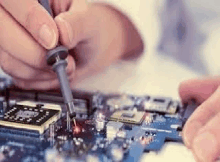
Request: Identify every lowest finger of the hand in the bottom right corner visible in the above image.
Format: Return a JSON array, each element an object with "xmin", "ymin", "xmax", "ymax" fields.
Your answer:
[{"xmin": 192, "ymin": 112, "xmax": 220, "ymax": 162}]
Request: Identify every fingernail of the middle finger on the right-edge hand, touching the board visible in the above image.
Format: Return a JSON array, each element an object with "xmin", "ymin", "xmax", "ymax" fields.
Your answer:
[{"xmin": 183, "ymin": 121, "xmax": 202, "ymax": 148}]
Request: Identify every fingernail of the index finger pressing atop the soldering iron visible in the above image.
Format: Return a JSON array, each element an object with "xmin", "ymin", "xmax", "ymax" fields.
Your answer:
[{"xmin": 39, "ymin": 24, "xmax": 56, "ymax": 49}]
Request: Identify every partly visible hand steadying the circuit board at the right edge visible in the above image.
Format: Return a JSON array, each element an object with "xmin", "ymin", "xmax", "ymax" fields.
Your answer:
[{"xmin": 179, "ymin": 77, "xmax": 220, "ymax": 162}]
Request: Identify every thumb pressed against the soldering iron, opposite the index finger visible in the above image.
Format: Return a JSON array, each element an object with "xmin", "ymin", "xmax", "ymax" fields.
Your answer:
[{"xmin": 55, "ymin": 0, "xmax": 88, "ymax": 48}]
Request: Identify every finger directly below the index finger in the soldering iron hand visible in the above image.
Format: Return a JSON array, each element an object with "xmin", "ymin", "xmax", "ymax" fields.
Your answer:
[{"xmin": 0, "ymin": 5, "xmax": 47, "ymax": 69}]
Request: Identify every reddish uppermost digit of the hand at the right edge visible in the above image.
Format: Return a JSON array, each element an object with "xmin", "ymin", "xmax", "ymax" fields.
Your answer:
[{"xmin": 179, "ymin": 77, "xmax": 220, "ymax": 103}]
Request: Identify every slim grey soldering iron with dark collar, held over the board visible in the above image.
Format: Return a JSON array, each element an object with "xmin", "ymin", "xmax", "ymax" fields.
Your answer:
[{"xmin": 39, "ymin": 0, "xmax": 76, "ymax": 126}]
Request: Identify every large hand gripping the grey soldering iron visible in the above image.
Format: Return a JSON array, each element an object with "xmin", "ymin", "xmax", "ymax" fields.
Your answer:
[{"xmin": 0, "ymin": 0, "xmax": 143, "ymax": 89}]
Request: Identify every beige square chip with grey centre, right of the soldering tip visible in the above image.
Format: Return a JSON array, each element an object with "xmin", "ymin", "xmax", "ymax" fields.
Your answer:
[{"xmin": 110, "ymin": 110, "xmax": 145, "ymax": 124}]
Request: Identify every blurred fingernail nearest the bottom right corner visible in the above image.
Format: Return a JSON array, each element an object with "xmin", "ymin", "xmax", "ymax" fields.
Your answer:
[{"xmin": 193, "ymin": 132, "xmax": 218, "ymax": 162}]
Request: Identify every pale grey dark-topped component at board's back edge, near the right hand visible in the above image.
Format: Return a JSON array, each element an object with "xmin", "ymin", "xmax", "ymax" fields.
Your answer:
[{"xmin": 143, "ymin": 97, "xmax": 178, "ymax": 114}]
